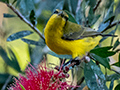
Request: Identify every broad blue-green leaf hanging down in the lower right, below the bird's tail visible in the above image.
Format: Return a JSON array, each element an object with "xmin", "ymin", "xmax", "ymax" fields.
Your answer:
[{"xmin": 84, "ymin": 60, "xmax": 108, "ymax": 90}]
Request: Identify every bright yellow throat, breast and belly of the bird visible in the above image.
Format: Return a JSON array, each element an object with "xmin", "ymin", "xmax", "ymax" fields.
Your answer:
[{"xmin": 44, "ymin": 14, "xmax": 101, "ymax": 58}]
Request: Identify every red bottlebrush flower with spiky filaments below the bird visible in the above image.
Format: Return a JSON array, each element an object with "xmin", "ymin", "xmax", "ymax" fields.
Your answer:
[{"xmin": 8, "ymin": 62, "xmax": 72, "ymax": 90}]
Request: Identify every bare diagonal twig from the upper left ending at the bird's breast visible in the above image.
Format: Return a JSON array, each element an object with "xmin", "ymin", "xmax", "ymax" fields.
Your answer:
[{"xmin": 7, "ymin": 4, "xmax": 45, "ymax": 40}]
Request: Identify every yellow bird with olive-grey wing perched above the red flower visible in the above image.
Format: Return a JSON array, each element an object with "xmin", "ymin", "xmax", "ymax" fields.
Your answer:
[{"xmin": 44, "ymin": 9, "xmax": 102, "ymax": 59}]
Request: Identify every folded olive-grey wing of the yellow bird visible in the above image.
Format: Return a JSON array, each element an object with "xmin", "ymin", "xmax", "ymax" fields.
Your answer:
[{"xmin": 62, "ymin": 21, "xmax": 101, "ymax": 40}]
